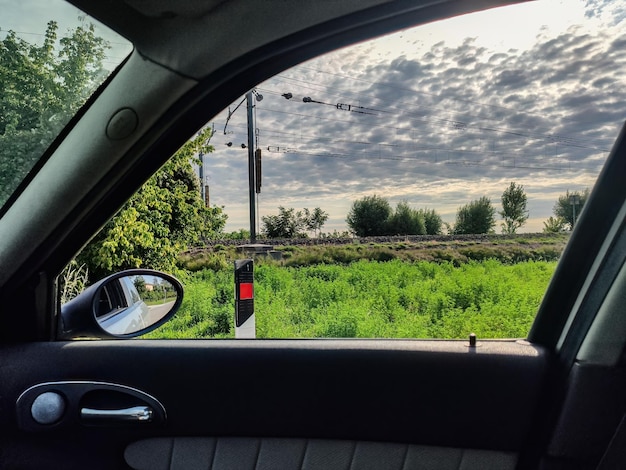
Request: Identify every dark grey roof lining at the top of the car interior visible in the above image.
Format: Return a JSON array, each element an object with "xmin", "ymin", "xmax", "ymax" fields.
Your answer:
[{"xmin": 71, "ymin": 0, "xmax": 518, "ymax": 79}]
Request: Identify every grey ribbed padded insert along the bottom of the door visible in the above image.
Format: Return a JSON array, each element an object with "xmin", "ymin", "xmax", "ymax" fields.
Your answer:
[{"xmin": 124, "ymin": 437, "xmax": 517, "ymax": 470}]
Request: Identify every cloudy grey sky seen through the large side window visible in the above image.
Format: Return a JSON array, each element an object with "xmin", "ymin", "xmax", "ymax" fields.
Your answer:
[{"xmin": 199, "ymin": 0, "xmax": 626, "ymax": 232}]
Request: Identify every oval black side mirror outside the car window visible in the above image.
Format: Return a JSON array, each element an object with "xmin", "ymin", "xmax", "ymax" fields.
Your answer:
[{"xmin": 58, "ymin": 269, "xmax": 183, "ymax": 339}]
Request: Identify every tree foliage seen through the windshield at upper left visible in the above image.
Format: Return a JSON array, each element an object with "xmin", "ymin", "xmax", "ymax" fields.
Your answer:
[{"xmin": 0, "ymin": 21, "xmax": 108, "ymax": 204}]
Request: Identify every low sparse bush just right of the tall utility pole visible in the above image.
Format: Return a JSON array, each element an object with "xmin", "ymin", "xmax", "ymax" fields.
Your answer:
[{"xmin": 261, "ymin": 206, "xmax": 328, "ymax": 238}]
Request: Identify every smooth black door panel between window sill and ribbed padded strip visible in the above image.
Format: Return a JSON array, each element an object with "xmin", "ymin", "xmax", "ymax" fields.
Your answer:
[{"xmin": 0, "ymin": 340, "xmax": 549, "ymax": 468}]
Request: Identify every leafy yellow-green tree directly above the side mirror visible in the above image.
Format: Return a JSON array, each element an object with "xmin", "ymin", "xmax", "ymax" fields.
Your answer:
[{"xmin": 78, "ymin": 128, "xmax": 227, "ymax": 278}]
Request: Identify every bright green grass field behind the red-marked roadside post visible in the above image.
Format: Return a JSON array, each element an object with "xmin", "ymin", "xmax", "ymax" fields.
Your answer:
[{"xmin": 146, "ymin": 259, "xmax": 556, "ymax": 339}]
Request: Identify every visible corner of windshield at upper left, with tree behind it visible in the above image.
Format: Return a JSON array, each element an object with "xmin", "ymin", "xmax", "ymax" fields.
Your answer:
[{"xmin": 0, "ymin": 0, "xmax": 131, "ymax": 209}]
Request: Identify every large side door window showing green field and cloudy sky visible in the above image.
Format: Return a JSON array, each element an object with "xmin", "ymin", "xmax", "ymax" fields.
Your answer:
[{"xmin": 61, "ymin": 2, "xmax": 626, "ymax": 338}]
